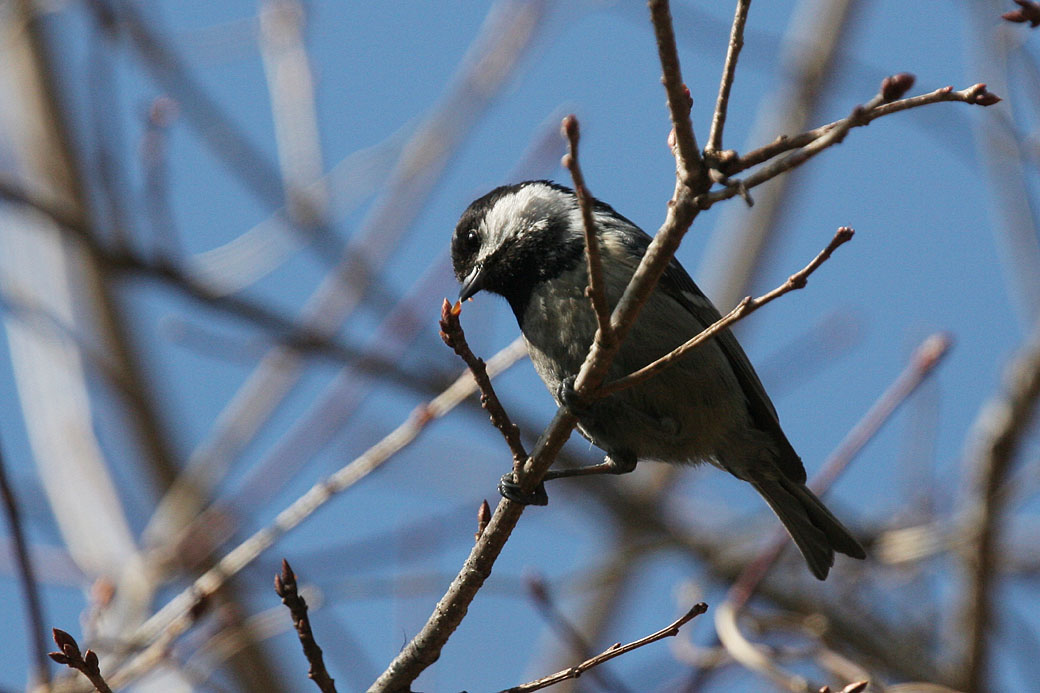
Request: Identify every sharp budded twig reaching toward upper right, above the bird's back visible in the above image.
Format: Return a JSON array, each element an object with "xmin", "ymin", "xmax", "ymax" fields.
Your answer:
[{"xmin": 709, "ymin": 79, "xmax": 1000, "ymax": 178}]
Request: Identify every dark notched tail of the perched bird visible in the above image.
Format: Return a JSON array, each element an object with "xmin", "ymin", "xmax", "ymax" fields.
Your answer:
[{"xmin": 751, "ymin": 478, "xmax": 866, "ymax": 580}]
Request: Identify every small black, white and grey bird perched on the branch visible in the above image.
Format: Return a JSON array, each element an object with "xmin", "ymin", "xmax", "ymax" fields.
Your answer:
[{"xmin": 451, "ymin": 180, "xmax": 865, "ymax": 580}]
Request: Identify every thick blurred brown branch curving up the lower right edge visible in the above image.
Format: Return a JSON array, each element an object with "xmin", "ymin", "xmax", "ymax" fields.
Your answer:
[{"xmin": 962, "ymin": 322, "xmax": 1040, "ymax": 692}]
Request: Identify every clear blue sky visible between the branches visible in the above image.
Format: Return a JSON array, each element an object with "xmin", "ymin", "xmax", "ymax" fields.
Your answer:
[{"xmin": 0, "ymin": 0, "xmax": 1037, "ymax": 691}]
